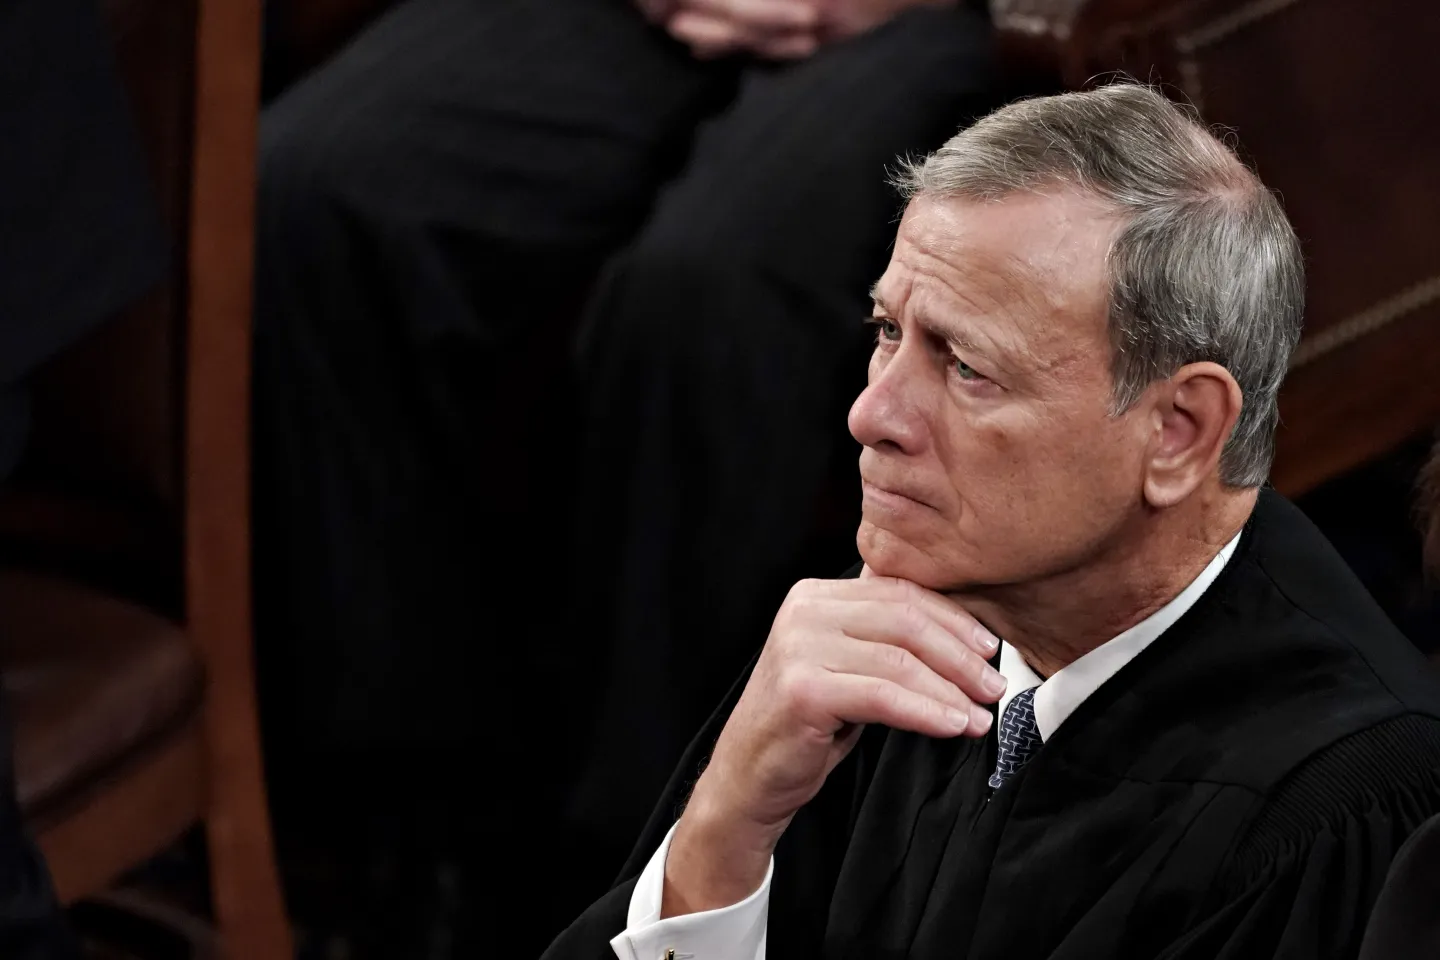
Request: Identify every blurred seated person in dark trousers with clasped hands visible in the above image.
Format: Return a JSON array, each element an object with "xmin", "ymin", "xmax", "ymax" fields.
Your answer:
[{"xmin": 247, "ymin": 0, "xmax": 1019, "ymax": 949}]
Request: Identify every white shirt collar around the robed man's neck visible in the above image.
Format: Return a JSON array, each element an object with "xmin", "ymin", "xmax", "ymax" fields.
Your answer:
[{"xmin": 998, "ymin": 534, "xmax": 1240, "ymax": 741}]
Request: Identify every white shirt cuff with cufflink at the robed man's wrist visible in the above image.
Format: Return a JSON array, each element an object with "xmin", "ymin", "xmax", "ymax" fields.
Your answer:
[{"xmin": 611, "ymin": 826, "xmax": 775, "ymax": 960}]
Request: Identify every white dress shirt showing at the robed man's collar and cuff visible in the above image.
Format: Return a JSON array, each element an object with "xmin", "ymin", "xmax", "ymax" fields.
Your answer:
[{"xmin": 611, "ymin": 534, "xmax": 1240, "ymax": 960}]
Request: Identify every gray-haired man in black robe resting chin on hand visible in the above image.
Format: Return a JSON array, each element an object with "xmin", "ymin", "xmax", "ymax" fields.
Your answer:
[{"xmin": 547, "ymin": 85, "xmax": 1440, "ymax": 960}]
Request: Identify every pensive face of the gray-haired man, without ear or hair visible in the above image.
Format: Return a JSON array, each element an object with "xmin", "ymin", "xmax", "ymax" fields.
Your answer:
[{"xmin": 850, "ymin": 190, "xmax": 1151, "ymax": 590}]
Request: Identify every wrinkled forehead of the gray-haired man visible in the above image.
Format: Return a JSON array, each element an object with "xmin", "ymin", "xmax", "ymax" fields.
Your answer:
[{"xmin": 873, "ymin": 191, "xmax": 1119, "ymax": 374}]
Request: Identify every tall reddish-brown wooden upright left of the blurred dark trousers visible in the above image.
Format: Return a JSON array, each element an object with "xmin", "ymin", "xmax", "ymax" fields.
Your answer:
[{"xmin": 184, "ymin": 0, "xmax": 292, "ymax": 959}]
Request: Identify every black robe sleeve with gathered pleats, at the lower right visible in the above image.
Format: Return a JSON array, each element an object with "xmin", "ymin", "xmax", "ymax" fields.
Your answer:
[{"xmin": 1152, "ymin": 715, "xmax": 1440, "ymax": 960}]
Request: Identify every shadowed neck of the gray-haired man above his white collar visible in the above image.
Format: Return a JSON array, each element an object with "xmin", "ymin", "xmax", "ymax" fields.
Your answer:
[{"xmin": 956, "ymin": 489, "xmax": 1257, "ymax": 676}]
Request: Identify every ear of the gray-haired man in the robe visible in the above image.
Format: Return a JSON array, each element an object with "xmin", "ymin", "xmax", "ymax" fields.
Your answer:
[{"xmin": 1145, "ymin": 363, "xmax": 1241, "ymax": 507}]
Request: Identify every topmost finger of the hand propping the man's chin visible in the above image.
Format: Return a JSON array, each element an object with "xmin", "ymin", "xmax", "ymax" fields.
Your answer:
[{"xmin": 834, "ymin": 602, "xmax": 1005, "ymax": 704}]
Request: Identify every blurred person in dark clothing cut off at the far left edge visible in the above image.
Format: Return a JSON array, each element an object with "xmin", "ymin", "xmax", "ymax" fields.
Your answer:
[{"xmin": 0, "ymin": 0, "xmax": 166, "ymax": 960}]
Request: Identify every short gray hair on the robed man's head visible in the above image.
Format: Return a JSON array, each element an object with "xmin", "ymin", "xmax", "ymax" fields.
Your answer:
[{"xmin": 896, "ymin": 83, "xmax": 1305, "ymax": 486}]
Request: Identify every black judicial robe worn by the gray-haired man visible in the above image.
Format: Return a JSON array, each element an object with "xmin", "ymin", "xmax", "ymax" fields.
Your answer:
[{"xmin": 546, "ymin": 491, "xmax": 1440, "ymax": 960}]
